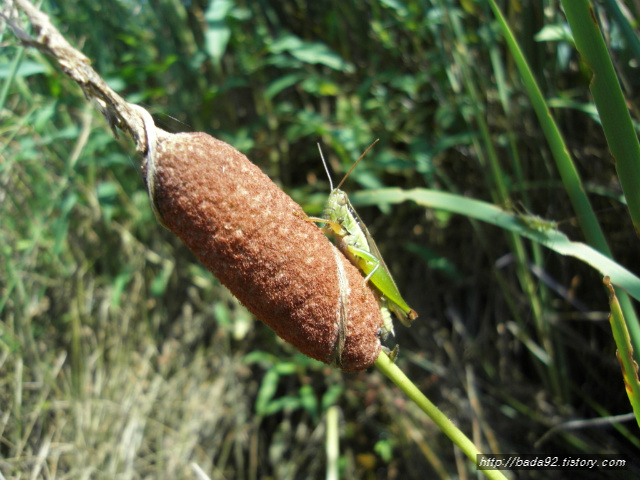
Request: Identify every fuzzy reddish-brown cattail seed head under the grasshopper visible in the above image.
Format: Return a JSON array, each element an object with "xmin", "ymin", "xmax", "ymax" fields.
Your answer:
[{"xmin": 147, "ymin": 133, "xmax": 382, "ymax": 372}]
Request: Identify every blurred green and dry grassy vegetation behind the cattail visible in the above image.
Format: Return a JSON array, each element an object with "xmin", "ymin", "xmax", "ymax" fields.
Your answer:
[{"xmin": 0, "ymin": 0, "xmax": 640, "ymax": 479}]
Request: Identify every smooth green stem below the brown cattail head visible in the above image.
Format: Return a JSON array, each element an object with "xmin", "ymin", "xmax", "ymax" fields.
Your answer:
[{"xmin": 376, "ymin": 352, "xmax": 506, "ymax": 480}]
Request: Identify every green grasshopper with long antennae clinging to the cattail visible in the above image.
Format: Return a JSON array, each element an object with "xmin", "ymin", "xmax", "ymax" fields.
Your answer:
[{"xmin": 309, "ymin": 140, "xmax": 418, "ymax": 339}]
